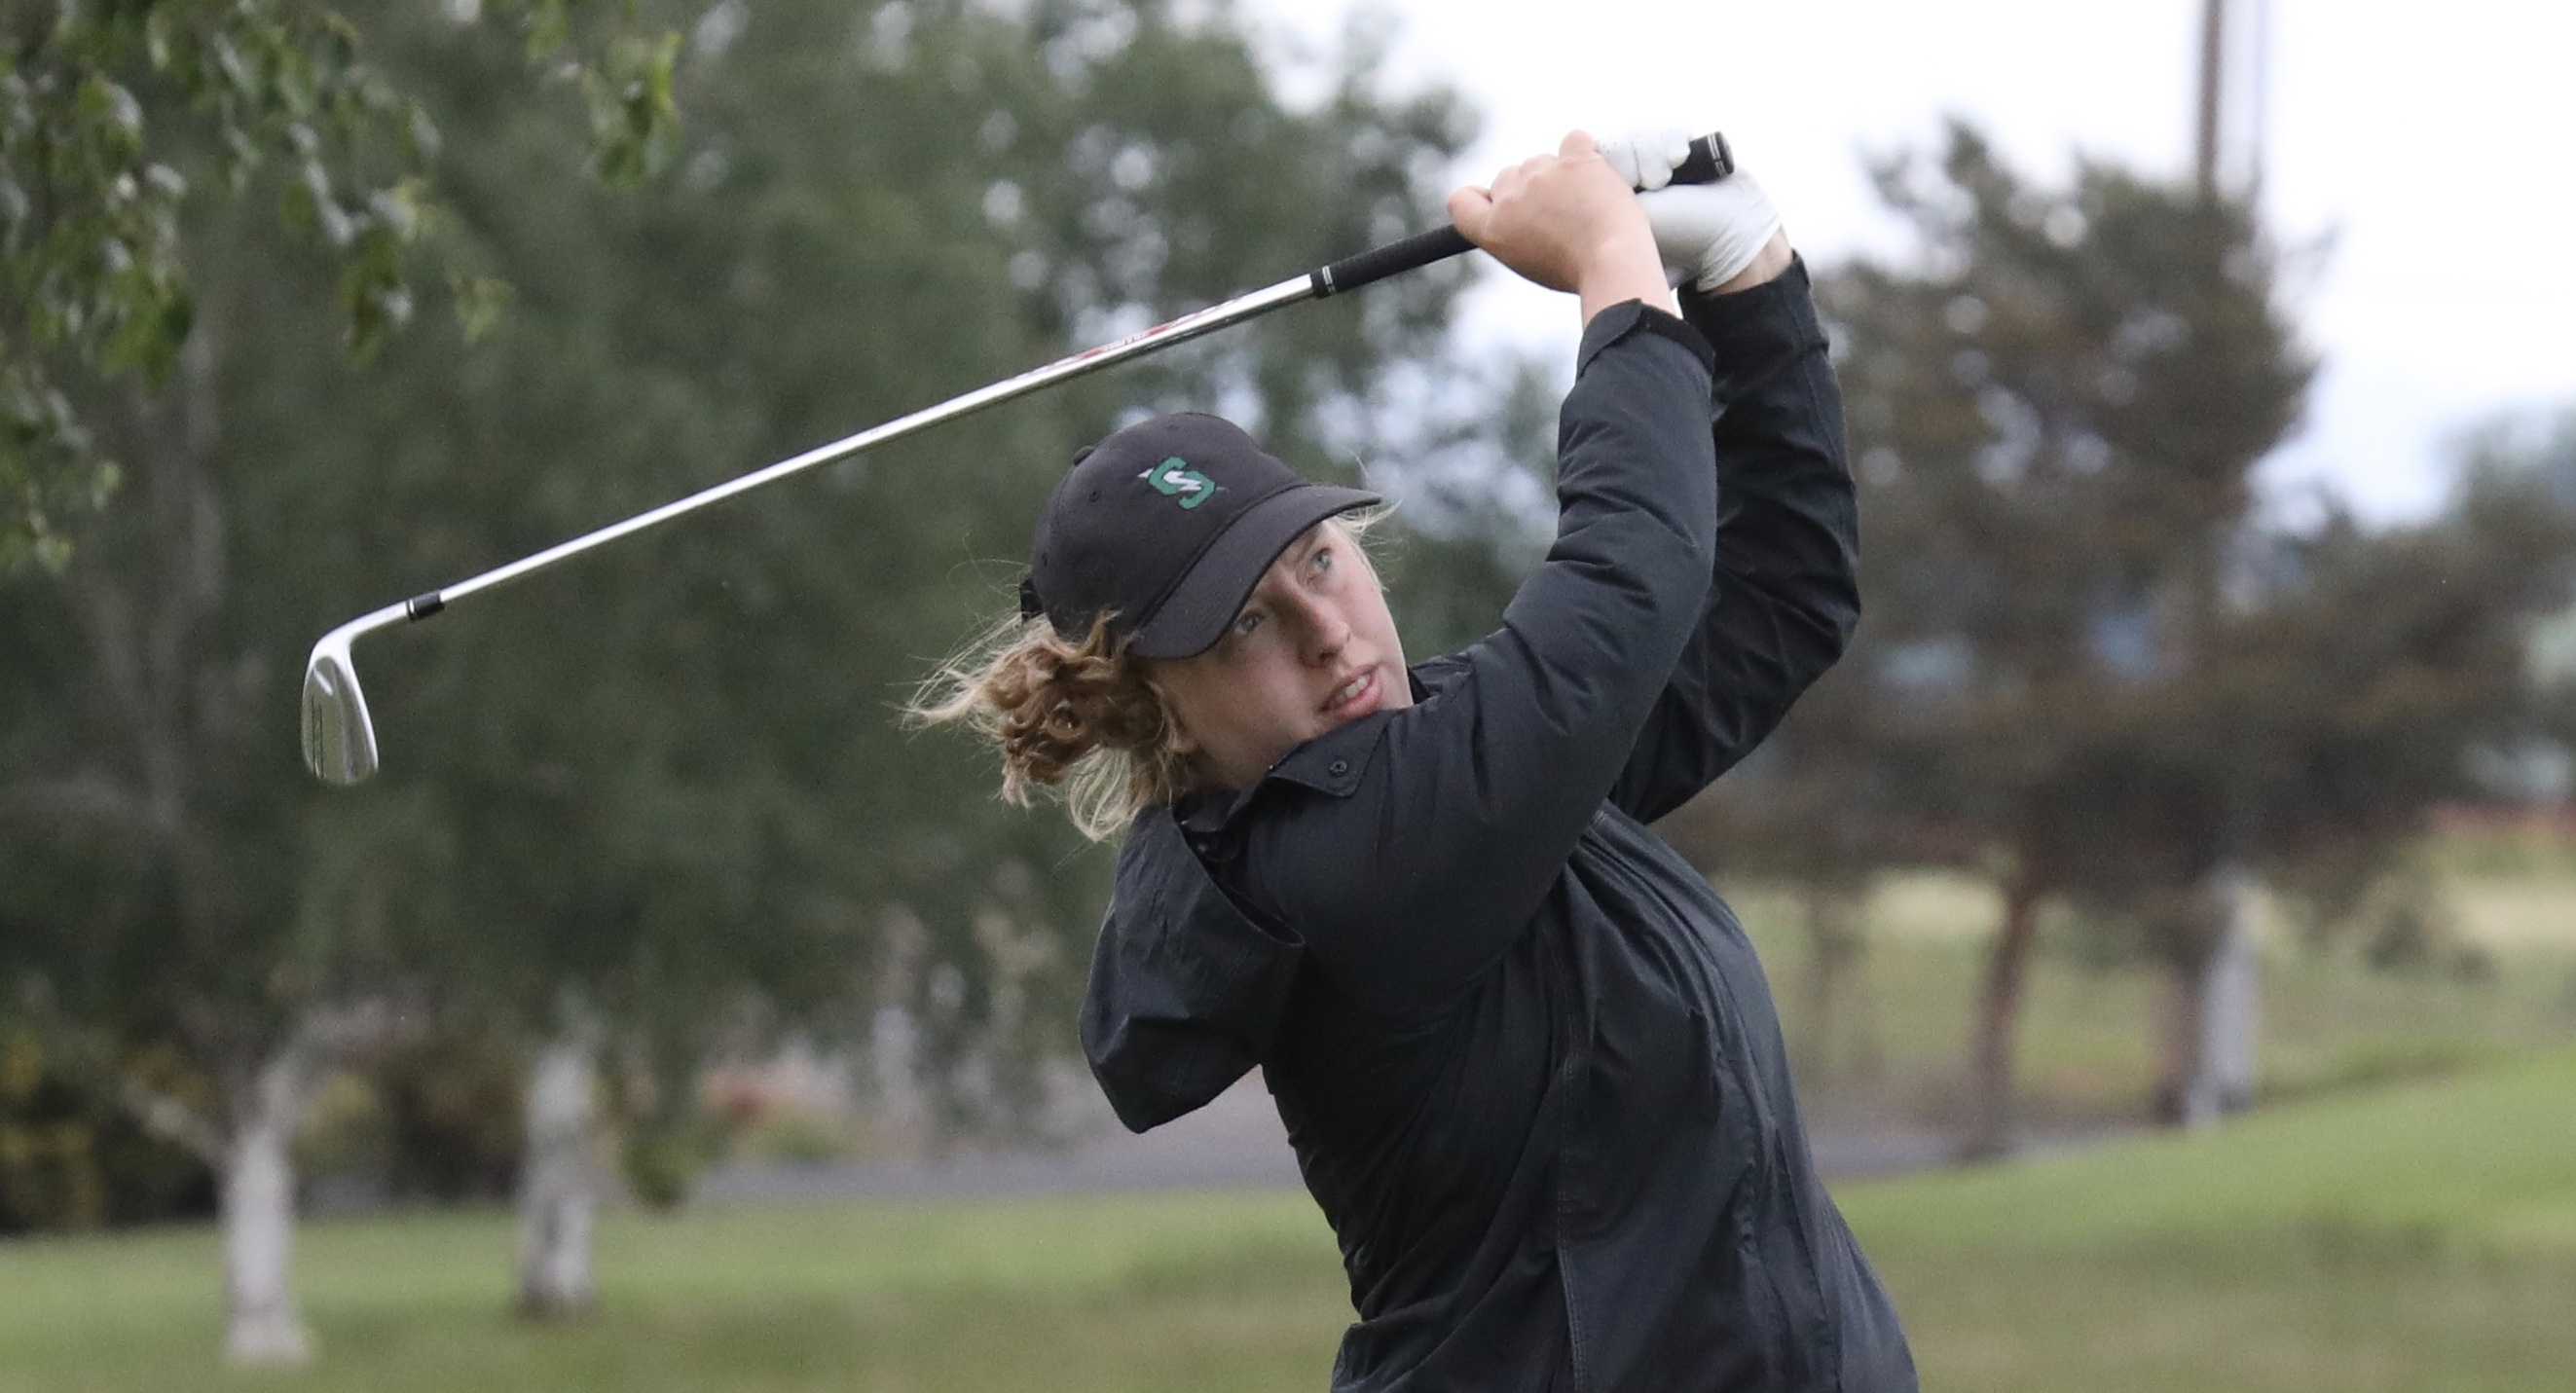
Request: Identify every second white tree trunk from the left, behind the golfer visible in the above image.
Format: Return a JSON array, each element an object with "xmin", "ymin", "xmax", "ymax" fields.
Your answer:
[{"xmin": 518, "ymin": 1008, "xmax": 598, "ymax": 1321}]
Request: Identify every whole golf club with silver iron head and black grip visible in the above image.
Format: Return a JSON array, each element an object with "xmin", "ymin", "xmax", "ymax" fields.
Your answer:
[{"xmin": 304, "ymin": 134, "xmax": 1734, "ymax": 786}]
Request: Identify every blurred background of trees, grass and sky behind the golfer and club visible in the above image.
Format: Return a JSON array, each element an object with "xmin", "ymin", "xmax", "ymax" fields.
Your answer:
[{"xmin": 0, "ymin": 0, "xmax": 2576, "ymax": 1390}]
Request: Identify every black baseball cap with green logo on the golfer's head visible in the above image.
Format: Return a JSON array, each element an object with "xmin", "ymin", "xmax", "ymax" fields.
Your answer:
[{"xmin": 1020, "ymin": 412, "xmax": 1379, "ymax": 659}]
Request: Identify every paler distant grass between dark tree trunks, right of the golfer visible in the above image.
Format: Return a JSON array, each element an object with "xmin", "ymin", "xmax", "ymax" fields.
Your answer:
[{"xmin": 1721, "ymin": 853, "xmax": 2576, "ymax": 1128}]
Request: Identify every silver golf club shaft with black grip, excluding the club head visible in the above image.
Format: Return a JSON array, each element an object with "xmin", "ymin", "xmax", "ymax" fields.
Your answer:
[{"xmin": 368, "ymin": 134, "xmax": 1734, "ymax": 620}]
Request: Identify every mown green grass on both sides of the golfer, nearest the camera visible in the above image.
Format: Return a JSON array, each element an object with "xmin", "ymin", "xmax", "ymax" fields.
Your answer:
[{"xmin": 0, "ymin": 1050, "xmax": 2576, "ymax": 1393}]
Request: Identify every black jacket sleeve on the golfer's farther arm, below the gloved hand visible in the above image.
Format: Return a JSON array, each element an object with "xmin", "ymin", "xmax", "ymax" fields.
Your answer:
[{"xmin": 1610, "ymin": 260, "xmax": 1859, "ymax": 822}]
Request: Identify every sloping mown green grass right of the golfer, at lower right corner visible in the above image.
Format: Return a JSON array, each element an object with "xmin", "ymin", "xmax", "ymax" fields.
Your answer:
[{"xmin": 1847, "ymin": 1053, "xmax": 2576, "ymax": 1393}]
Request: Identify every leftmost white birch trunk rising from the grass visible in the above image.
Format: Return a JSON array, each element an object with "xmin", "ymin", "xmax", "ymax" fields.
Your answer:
[{"xmin": 222, "ymin": 1048, "xmax": 312, "ymax": 1368}]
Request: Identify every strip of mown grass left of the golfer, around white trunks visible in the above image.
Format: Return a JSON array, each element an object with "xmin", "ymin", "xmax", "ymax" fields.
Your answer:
[{"xmin": 0, "ymin": 1192, "xmax": 1347, "ymax": 1393}]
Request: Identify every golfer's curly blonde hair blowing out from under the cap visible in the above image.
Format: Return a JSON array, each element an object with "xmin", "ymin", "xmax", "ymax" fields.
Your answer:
[{"xmin": 904, "ymin": 507, "xmax": 1391, "ymax": 842}]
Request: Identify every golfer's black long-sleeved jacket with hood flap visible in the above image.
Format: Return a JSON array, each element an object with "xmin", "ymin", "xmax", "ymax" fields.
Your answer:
[{"xmin": 1082, "ymin": 265, "xmax": 1917, "ymax": 1393}]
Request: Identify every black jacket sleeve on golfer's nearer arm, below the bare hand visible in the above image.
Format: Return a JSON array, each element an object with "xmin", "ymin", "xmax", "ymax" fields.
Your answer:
[{"xmin": 1244, "ymin": 301, "xmax": 1715, "ymax": 1014}]
